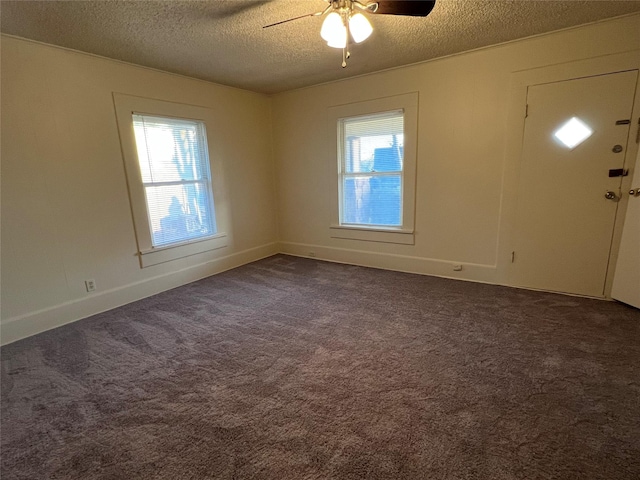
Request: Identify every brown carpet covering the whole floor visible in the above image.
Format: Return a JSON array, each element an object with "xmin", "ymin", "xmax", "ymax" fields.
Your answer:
[{"xmin": 0, "ymin": 255, "xmax": 640, "ymax": 480}]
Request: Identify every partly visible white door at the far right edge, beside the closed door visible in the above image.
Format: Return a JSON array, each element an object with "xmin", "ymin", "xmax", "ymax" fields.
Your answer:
[{"xmin": 611, "ymin": 151, "xmax": 640, "ymax": 308}]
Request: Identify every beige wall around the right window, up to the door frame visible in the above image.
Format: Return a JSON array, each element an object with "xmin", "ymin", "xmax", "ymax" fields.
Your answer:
[{"xmin": 273, "ymin": 15, "xmax": 640, "ymax": 283}]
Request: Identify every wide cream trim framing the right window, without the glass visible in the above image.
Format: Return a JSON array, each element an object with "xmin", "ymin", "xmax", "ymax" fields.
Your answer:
[{"xmin": 328, "ymin": 92, "xmax": 418, "ymax": 245}]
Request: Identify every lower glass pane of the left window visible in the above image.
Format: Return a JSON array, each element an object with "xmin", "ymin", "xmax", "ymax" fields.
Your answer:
[{"xmin": 145, "ymin": 183, "xmax": 216, "ymax": 246}]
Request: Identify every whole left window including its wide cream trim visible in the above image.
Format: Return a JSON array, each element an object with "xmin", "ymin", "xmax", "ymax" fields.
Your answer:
[{"xmin": 113, "ymin": 93, "xmax": 229, "ymax": 268}]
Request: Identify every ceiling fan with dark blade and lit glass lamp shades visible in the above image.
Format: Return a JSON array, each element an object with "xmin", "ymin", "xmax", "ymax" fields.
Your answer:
[{"xmin": 262, "ymin": 0, "xmax": 436, "ymax": 68}]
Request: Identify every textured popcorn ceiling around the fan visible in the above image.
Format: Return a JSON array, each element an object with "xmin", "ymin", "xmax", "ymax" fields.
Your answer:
[{"xmin": 0, "ymin": 0, "xmax": 640, "ymax": 93}]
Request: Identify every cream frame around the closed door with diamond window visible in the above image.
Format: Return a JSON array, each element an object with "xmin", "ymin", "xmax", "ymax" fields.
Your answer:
[{"xmin": 497, "ymin": 50, "xmax": 640, "ymax": 298}]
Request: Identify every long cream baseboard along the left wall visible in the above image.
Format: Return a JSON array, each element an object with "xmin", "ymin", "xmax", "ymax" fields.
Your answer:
[{"xmin": 0, "ymin": 243, "xmax": 278, "ymax": 345}]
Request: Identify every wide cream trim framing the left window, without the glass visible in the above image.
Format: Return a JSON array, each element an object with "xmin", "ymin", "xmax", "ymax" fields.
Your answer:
[{"xmin": 113, "ymin": 93, "xmax": 228, "ymax": 268}]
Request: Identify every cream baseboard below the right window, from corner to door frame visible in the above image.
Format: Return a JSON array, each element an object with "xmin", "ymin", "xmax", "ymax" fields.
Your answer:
[{"xmin": 278, "ymin": 242, "xmax": 498, "ymax": 285}]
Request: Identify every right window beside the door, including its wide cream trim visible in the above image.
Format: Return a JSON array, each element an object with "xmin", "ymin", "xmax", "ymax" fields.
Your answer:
[{"xmin": 328, "ymin": 93, "xmax": 418, "ymax": 245}]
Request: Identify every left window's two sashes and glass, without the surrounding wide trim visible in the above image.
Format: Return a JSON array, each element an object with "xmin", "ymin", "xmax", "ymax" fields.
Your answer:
[{"xmin": 133, "ymin": 114, "xmax": 216, "ymax": 247}]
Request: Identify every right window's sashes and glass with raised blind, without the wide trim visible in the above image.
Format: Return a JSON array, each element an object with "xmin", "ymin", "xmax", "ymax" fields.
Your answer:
[{"xmin": 339, "ymin": 111, "xmax": 404, "ymax": 227}]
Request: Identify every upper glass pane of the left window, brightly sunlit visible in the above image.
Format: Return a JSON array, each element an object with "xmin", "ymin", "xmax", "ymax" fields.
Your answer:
[{"xmin": 133, "ymin": 115, "xmax": 208, "ymax": 183}]
